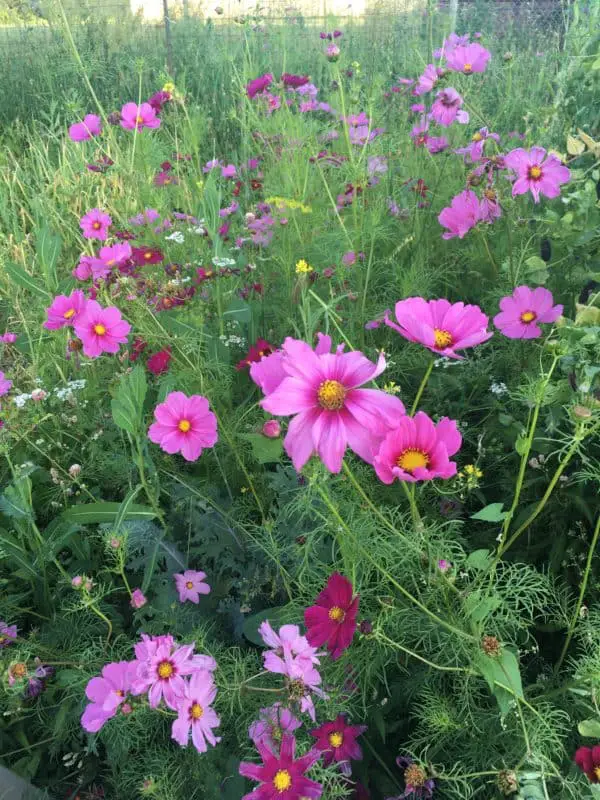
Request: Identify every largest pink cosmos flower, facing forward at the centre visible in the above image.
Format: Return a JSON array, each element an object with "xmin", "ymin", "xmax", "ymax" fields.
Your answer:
[{"xmin": 260, "ymin": 338, "xmax": 404, "ymax": 472}]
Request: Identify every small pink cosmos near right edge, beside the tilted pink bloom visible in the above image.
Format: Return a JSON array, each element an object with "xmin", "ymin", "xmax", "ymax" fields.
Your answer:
[{"xmin": 494, "ymin": 286, "xmax": 563, "ymax": 339}]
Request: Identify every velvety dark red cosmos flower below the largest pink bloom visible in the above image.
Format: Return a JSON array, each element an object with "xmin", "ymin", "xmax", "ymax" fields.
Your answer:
[{"xmin": 304, "ymin": 572, "xmax": 359, "ymax": 660}]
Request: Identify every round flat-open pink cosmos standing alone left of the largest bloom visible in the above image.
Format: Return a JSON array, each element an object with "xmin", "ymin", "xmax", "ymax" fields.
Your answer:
[{"xmin": 148, "ymin": 392, "xmax": 219, "ymax": 461}]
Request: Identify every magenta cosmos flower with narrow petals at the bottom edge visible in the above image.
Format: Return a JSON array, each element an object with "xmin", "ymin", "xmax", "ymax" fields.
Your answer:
[{"xmin": 240, "ymin": 733, "xmax": 323, "ymax": 800}]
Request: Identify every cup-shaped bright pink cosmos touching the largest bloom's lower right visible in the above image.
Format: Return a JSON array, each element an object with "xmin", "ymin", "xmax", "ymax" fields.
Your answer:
[{"xmin": 373, "ymin": 411, "xmax": 462, "ymax": 483}]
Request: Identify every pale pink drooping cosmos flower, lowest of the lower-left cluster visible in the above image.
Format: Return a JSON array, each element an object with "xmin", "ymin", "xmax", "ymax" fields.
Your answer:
[{"xmin": 171, "ymin": 671, "xmax": 221, "ymax": 753}]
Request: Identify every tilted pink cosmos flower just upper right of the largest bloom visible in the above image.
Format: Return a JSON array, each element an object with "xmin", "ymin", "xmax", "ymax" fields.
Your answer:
[{"xmin": 385, "ymin": 297, "xmax": 493, "ymax": 359}]
